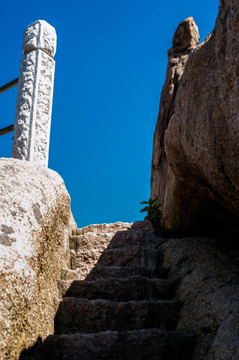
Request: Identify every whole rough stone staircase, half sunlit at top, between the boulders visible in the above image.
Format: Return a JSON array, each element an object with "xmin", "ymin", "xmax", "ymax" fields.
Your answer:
[{"xmin": 22, "ymin": 221, "xmax": 195, "ymax": 360}]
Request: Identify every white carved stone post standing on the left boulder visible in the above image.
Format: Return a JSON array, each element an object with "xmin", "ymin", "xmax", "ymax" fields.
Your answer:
[{"xmin": 12, "ymin": 20, "xmax": 56, "ymax": 167}]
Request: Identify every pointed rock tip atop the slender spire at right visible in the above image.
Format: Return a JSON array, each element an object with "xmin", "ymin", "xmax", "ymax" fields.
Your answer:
[{"xmin": 172, "ymin": 16, "xmax": 200, "ymax": 51}]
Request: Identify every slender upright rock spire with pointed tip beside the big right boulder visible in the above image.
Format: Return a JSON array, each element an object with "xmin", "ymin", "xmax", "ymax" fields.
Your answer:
[{"xmin": 151, "ymin": 18, "xmax": 199, "ymax": 208}]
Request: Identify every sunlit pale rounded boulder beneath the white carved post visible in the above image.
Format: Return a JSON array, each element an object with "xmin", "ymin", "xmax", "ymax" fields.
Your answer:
[{"xmin": 0, "ymin": 159, "xmax": 74, "ymax": 360}]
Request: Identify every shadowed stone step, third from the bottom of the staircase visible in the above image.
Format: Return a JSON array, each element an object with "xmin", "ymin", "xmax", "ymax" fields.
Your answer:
[{"xmin": 63, "ymin": 276, "xmax": 176, "ymax": 301}]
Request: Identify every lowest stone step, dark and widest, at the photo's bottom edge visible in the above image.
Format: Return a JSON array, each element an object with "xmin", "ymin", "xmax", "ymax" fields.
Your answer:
[{"xmin": 25, "ymin": 329, "xmax": 195, "ymax": 360}]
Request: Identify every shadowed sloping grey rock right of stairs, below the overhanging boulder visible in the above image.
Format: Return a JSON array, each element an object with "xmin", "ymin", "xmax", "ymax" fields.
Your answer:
[{"xmin": 162, "ymin": 237, "xmax": 239, "ymax": 360}]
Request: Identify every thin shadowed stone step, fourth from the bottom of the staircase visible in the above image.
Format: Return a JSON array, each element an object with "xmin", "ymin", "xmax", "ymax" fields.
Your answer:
[{"xmin": 86, "ymin": 266, "xmax": 170, "ymax": 280}]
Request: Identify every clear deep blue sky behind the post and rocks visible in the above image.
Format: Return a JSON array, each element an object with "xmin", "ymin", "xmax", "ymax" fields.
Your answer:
[{"xmin": 0, "ymin": 0, "xmax": 219, "ymax": 227}]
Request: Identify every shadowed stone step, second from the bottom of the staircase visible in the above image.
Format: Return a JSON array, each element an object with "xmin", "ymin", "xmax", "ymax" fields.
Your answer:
[{"xmin": 55, "ymin": 297, "xmax": 181, "ymax": 334}]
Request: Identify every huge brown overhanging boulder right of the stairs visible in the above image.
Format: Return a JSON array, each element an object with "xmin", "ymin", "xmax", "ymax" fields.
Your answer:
[{"xmin": 151, "ymin": 0, "xmax": 239, "ymax": 233}]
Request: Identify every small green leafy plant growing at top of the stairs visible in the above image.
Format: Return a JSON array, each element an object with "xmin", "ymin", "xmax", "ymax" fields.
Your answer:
[{"xmin": 140, "ymin": 199, "xmax": 163, "ymax": 232}]
